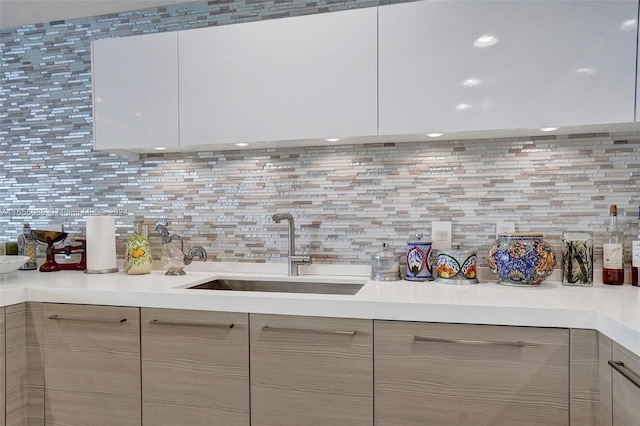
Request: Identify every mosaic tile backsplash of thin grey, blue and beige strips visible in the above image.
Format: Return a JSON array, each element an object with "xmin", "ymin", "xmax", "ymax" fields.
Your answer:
[{"xmin": 0, "ymin": 0, "xmax": 640, "ymax": 264}]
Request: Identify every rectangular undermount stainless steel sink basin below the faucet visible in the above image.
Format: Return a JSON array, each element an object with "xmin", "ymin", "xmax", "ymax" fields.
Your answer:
[{"xmin": 189, "ymin": 279, "xmax": 364, "ymax": 294}]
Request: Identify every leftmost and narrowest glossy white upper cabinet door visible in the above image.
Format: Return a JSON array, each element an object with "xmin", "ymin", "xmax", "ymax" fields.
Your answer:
[{"xmin": 93, "ymin": 33, "xmax": 179, "ymax": 150}]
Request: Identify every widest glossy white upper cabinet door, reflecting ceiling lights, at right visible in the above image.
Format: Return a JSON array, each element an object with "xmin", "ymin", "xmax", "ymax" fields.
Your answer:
[{"xmin": 379, "ymin": 0, "xmax": 638, "ymax": 135}]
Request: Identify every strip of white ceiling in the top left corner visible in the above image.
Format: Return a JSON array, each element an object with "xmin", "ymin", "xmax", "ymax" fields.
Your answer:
[{"xmin": 0, "ymin": 0, "xmax": 193, "ymax": 28}]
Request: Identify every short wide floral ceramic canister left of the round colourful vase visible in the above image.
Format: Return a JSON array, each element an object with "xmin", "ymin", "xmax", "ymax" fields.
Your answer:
[{"xmin": 434, "ymin": 246, "xmax": 478, "ymax": 284}]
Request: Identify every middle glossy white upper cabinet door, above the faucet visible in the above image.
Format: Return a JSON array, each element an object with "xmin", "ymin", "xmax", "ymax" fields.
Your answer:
[{"xmin": 179, "ymin": 7, "xmax": 377, "ymax": 145}]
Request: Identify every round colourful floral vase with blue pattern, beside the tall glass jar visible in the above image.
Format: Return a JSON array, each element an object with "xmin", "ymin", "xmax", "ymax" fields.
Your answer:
[{"xmin": 487, "ymin": 232, "xmax": 556, "ymax": 286}]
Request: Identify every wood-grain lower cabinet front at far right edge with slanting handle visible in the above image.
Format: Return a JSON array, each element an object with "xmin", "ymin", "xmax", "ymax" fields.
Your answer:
[{"xmin": 609, "ymin": 343, "xmax": 640, "ymax": 426}]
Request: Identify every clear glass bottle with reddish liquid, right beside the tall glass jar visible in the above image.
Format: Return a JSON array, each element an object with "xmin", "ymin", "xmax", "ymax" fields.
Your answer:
[{"xmin": 602, "ymin": 204, "xmax": 624, "ymax": 285}]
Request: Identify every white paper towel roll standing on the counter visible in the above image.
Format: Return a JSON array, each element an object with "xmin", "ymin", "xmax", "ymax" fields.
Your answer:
[{"xmin": 85, "ymin": 216, "xmax": 118, "ymax": 274}]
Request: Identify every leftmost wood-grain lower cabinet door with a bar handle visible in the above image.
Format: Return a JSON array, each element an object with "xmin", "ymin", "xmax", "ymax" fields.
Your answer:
[{"xmin": 44, "ymin": 304, "xmax": 142, "ymax": 426}]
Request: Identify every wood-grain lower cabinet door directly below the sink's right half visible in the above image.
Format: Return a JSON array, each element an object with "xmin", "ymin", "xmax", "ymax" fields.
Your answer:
[{"xmin": 250, "ymin": 314, "xmax": 372, "ymax": 426}]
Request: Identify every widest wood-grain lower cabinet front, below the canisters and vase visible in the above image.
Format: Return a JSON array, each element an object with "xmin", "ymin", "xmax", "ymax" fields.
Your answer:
[{"xmin": 374, "ymin": 321, "xmax": 569, "ymax": 426}]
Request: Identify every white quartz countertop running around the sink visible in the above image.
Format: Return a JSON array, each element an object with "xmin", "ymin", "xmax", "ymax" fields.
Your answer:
[{"xmin": 0, "ymin": 263, "xmax": 640, "ymax": 355}]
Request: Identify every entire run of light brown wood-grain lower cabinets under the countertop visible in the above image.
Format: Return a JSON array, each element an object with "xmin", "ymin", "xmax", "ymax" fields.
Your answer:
[{"xmin": 0, "ymin": 303, "xmax": 640, "ymax": 426}]
